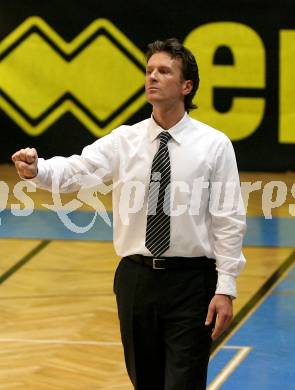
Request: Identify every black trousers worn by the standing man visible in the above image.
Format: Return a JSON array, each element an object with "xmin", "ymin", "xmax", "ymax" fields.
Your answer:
[{"xmin": 114, "ymin": 257, "xmax": 217, "ymax": 390}]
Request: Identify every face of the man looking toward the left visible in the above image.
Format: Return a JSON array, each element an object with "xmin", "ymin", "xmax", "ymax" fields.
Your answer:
[{"xmin": 145, "ymin": 52, "xmax": 187, "ymax": 106}]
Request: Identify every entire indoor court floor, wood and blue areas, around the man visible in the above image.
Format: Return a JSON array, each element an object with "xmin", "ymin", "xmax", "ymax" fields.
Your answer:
[{"xmin": 0, "ymin": 165, "xmax": 295, "ymax": 390}]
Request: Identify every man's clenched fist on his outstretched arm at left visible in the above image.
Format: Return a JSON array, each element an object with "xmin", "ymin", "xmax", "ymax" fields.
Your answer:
[{"xmin": 11, "ymin": 148, "xmax": 38, "ymax": 179}]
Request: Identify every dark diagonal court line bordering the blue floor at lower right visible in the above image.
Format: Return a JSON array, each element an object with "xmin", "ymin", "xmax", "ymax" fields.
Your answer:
[{"xmin": 211, "ymin": 250, "xmax": 295, "ymax": 354}]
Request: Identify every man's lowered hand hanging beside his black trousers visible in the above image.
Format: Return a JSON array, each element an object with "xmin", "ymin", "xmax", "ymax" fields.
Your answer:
[{"xmin": 205, "ymin": 294, "xmax": 233, "ymax": 340}]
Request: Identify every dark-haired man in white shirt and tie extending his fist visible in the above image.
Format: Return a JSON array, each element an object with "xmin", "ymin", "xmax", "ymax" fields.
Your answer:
[{"xmin": 12, "ymin": 39, "xmax": 246, "ymax": 390}]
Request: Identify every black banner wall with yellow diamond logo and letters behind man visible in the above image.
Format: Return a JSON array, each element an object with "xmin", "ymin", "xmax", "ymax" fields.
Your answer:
[{"xmin": 0, "ymin": 0, "xmax": 295, "ymax": 171}]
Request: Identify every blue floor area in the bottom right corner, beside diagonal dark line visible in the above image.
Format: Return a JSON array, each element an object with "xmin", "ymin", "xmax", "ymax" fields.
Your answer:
[{"xmin": 208, "ymin": 269, "xmax": 295, "ymax": 390}]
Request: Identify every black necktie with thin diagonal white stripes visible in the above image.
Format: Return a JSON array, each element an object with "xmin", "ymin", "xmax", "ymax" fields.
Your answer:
[{"xmin": 145, "ymin": 131, "xmax": 171, "ymax": 257}]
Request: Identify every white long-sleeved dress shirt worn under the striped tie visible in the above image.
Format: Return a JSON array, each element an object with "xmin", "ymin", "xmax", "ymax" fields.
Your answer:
[{"xmin": 32, "ymin": 114, "xmax": 246, "ymax": 297}]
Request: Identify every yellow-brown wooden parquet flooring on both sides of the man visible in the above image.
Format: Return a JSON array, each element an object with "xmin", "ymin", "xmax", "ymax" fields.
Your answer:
[{"xmin": 0, "ymin": 166, "xmax": 294, "ymax": 390}]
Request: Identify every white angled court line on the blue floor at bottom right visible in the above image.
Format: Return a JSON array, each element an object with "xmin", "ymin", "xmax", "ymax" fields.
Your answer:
[{"xmin": 207, "ymin": 345, "xmax": 252, "ymax": 390}]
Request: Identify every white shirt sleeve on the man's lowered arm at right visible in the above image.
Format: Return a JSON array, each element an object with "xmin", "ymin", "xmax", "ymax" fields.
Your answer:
[{"xmin": 209, "ymin": 138, "xmax": 246, "ymax": 298}]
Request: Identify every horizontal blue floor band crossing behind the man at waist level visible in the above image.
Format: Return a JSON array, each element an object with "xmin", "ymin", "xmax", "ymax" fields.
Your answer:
[{"xmin": 0, "ymin": 209, "xmax": 295, "ymax": 247}]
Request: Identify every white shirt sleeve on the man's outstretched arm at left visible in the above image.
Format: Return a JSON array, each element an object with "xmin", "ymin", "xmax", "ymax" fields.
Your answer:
[{"xmin": 29, "ymin": 131, "xmax": 118, "ymax": 192}]
